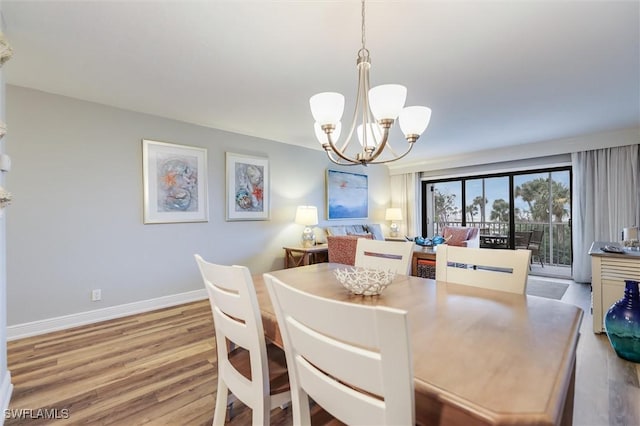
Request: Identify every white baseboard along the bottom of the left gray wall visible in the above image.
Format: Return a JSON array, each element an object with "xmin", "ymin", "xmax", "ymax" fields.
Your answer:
[{"xmin": 7, "ymin": 289, "xmax": 208, "ymax": 341}]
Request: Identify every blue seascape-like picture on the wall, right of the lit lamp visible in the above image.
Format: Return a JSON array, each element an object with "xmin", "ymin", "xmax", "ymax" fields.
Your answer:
[{"xmin": 326, "ymin": 169, "xmax": 369, "ymax": 220}]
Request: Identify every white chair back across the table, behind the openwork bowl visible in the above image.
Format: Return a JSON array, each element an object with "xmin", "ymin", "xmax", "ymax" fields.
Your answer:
[{"xmin": 355, "ymin": 238, "xmax": 414, "ymax": 275}]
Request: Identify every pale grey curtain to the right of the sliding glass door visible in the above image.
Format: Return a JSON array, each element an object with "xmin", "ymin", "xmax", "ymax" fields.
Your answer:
[{"xmin": 571, "ymin": 144, "xmax": 640, "ymax": 283}]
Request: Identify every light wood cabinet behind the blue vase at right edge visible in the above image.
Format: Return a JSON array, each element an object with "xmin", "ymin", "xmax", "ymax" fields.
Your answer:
[{"xmin": 589, "ymin": 241, "xmax": 640, "ymax": 333}]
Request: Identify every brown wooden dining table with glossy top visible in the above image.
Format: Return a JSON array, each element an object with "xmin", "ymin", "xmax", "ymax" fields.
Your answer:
[{"xmin": 254, "ymin": 263, "xmax": 583, "ymax": 425}]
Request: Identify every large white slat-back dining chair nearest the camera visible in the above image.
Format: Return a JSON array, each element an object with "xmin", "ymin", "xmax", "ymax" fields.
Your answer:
[{"xmin": 264, "ymin": 273, "xmax": 415, "ymax": 425}]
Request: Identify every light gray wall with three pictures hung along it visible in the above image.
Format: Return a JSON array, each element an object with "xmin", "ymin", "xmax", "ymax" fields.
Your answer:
[{"xmin": 6, "ymin": 86, "xmax": 390, "ymax": 325}]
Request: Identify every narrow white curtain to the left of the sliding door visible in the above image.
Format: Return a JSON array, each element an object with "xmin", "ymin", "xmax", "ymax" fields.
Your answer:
[{"xmin": 391, "ymin": 173, "xmax": 420, "ymax": 237}]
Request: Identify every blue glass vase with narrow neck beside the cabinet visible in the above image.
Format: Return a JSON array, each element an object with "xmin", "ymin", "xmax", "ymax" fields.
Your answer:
[{"xmin": 604, "ymin": 280, "xmax": 640, "ymax": 362}]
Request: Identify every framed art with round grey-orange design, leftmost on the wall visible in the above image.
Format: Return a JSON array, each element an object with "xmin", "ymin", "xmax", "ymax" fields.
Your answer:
[{"xmin": 142, "ymin": 139, "xmax": 209, "ymax": 224}]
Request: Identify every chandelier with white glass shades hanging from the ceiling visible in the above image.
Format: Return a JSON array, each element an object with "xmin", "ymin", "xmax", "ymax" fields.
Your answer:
[{"xmin": 309, "ymin": 0, "xmax": 431, "ymax": 166}]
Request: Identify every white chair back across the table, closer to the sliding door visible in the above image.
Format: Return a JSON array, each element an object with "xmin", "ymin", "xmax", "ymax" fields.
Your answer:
[{"xmin": 436, "ymin": 244, "xmax": 531, "ymax": 294}]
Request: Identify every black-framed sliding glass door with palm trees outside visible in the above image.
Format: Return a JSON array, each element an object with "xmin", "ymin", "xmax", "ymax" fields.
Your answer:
[{"xmin": 422, "ymin": 167, "xmax": 572, "ymax": 276}]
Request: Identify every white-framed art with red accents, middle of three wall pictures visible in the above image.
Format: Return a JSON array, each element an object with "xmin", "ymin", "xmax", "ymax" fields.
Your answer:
[{"xmin": 226, "ymin": 152, "xmax": 271, "ymax": 221}]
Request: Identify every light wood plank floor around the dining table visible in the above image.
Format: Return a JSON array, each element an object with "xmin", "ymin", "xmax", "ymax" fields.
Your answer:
[{"xmin": 5, "ymin": 283, "xmax": 640, "ymax": 426}]
